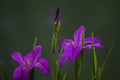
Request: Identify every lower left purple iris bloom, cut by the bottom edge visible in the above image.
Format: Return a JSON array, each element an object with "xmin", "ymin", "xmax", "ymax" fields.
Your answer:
[{"xmin": 11, "ymin": 45, "xmax": 49, "ymax": 80}]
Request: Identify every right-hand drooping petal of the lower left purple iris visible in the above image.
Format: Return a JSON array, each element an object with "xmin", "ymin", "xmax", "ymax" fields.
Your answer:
[{"xmin": 34, "ymin": 58, "xmax": 50, "ymax": 75}]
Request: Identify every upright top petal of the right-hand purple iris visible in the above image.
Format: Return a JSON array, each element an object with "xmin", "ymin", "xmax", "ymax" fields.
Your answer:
[{"xmin": 74, "ymin": 25, "xmax": 85, "ymax": 45}]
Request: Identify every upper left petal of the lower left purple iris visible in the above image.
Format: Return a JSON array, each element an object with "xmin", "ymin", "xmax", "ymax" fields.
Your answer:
[{"xmin": 11, "ymin": 52, "xmax": 25, "ymax": 65}]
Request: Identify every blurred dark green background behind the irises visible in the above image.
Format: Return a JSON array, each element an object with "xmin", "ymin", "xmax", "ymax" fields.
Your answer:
[{"xmin": 0, "ymin": 0, "xmax": 120, "ymax": 80}]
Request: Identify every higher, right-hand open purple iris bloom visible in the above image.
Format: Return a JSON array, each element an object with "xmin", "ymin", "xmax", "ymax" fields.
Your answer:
[{"xmin": 59, "ymin": 25, "xmax": 103, "ymax": 67}]
